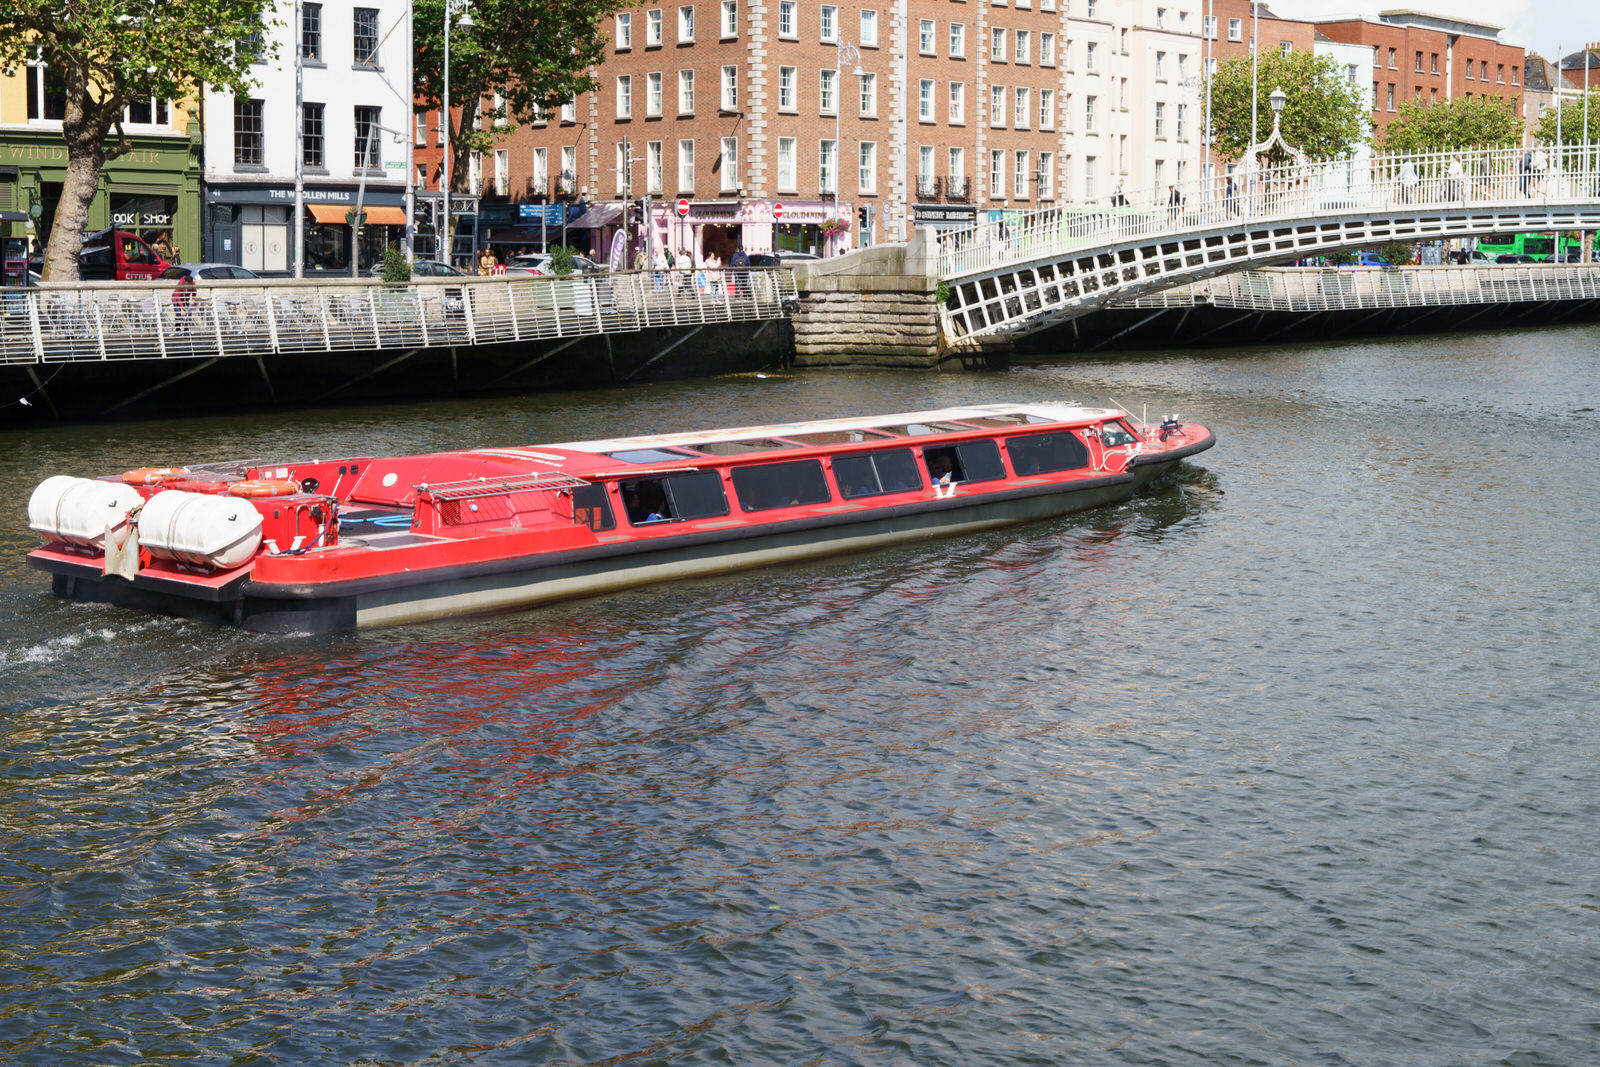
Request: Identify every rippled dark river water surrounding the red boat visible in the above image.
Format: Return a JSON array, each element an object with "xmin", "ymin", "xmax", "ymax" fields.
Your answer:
[{"xmin": 0, "ymin": 326, "xmax": 1600, "ymax": 1065}]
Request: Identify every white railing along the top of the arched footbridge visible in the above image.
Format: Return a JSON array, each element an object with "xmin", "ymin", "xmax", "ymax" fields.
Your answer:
[{"xmin": 938, "ymin": 146, "xmax": 1600, "ymax": 278}]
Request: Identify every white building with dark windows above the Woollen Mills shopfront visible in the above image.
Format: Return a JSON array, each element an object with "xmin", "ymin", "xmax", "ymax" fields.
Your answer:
[{"xmin": 202, "ymin": 0, "xmax": 413, "ymax": 275}]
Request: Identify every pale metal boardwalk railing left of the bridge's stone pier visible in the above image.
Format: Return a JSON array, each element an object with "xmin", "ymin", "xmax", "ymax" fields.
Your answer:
[{"xmin": 0, "ymin": 267, "xmax": 797, "ymax": 363}]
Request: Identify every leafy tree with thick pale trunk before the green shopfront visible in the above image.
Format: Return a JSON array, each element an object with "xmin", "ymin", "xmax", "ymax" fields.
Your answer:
[{"xmin": 0, "ymin": 0, "xmax": 267, "ymax": 282}]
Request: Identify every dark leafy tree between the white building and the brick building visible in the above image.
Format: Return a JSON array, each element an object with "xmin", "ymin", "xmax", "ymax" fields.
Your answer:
[{"xmin": 411, "ymin": 0, "xmax": 622, "ymax": 192}]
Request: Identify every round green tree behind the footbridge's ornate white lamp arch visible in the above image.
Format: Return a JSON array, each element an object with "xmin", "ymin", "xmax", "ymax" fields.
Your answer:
[{"xmin": 1211, "ymin": 51, "xmax": 1373, "ymax": 160}]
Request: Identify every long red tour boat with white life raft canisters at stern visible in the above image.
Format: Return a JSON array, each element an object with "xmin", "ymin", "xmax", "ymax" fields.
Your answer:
[{"xmin": 27, "ymin": 403, "xmax": 1214, "ymax": 632}]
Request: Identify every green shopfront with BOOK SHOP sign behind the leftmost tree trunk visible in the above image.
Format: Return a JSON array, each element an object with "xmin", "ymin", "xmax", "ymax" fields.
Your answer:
[{"xmin": 0, "ymin": 130, "xmax": 200, "ymax": 273}]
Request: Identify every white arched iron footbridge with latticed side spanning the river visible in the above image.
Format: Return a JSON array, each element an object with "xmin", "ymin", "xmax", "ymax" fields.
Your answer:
[{"xmin": 936, "ymin": 147, "xmax": 1600, "ymax": 347}]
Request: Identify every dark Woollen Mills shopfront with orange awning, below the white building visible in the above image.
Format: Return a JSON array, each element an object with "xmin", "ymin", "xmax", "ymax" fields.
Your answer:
[{"xmin": 205, "ymin": 184, "xmax": 406, "ymax": 277}]
